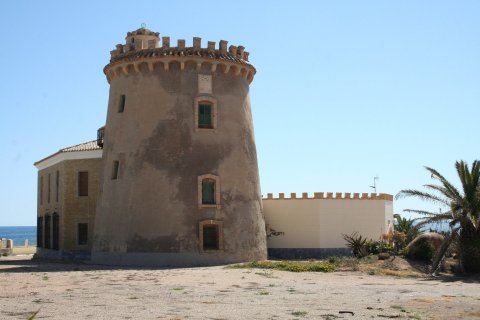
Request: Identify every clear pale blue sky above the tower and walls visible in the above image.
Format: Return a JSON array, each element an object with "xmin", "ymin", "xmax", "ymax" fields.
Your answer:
[{"xmin": 0, "ymin": 0, "xmax": 480, "ymax": 226}]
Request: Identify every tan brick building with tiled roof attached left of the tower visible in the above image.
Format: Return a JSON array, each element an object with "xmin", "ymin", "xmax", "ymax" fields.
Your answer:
[{"xmin": 35, "ymin": 141, "xmax": 102, "ymax": 258}]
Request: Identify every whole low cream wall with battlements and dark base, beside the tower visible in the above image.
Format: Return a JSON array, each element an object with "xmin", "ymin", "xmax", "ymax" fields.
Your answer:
[{"xmin": 263, "ymin": 192, "xmax": 393, "ymax": 259}]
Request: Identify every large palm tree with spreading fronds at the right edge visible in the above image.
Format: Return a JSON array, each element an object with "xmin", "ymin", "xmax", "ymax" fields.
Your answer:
[{"xmin": 395, "ymin": 160, "xmax": 480, "ymax": 273}]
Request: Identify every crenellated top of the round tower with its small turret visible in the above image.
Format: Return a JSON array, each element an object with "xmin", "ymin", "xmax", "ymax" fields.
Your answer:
[{"xmin": 103, "ymin": 28, "xmax": 256, "ymax": 83}]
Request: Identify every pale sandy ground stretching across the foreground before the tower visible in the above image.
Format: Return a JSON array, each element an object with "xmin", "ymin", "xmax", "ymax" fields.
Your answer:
[{"xmin": 0, "ymin": 256, "xmax": 480, "ymax": 320}]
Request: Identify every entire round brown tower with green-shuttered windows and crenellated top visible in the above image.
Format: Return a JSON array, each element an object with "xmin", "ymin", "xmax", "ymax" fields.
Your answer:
[{"xmin": 92, "ymin": 28, "xmax": 267, "ymax": 266}]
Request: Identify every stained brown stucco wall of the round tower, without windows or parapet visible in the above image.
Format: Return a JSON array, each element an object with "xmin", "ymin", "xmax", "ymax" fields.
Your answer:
[{"xmin": 92, "ymin": 45, "xmax": 266, "ymax": 265}]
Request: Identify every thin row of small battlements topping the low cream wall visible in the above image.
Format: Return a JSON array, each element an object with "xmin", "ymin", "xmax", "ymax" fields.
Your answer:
[{"xmin": 263, "ymin": 192, "xmax": 393, "ymax": 201}]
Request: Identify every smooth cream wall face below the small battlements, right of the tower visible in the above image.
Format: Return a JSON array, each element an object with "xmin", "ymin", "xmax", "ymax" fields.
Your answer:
[{"xmin": 263, "ymin": 195, "xmax": 393, "ymax": 248}]
